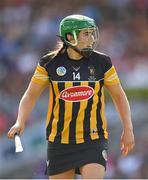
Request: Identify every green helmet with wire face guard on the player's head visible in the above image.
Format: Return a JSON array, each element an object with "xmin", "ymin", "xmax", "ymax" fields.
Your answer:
[{"xmin": 60, "ymin": 15, "xmax": 99, "ymax": 56}]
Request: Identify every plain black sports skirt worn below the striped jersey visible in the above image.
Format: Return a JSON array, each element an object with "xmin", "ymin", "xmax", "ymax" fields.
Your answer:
[{"xmin": 46, "ymin": 139, "xmax": 108, "ymax": 176}]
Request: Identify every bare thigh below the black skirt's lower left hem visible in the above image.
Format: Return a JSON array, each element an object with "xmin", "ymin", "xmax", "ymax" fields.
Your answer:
[{"xmin": 49, "ymin": 169, "xmax": 75, "ymax": 180}]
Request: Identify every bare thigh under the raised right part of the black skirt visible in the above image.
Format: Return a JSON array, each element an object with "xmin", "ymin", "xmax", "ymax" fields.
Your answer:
[{"xmin": 80, "ymin": 163, "xmax": 105, "ymax": 179}]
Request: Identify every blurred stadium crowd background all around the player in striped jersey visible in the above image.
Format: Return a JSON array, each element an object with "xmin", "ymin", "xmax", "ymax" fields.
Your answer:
[{"xmin": 0, "ymin": 0, "xmax": 148, "ymax": 179}]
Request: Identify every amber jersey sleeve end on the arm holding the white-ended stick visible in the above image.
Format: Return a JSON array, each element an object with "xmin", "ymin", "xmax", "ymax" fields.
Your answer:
[{"xmin": 31, "ymin": 64, "xmax": 49, "ymax": 86}]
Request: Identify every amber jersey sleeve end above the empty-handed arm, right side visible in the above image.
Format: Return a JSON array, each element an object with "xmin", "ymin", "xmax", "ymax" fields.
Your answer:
[{"xmin": 104, "ymin": 66, "xmax": 120, "ymax": 86}]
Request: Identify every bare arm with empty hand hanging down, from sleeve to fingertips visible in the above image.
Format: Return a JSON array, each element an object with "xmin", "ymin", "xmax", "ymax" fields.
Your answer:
[{"xmin": 106, "ymin": 83, "xmax": 135, "ymax": 156}]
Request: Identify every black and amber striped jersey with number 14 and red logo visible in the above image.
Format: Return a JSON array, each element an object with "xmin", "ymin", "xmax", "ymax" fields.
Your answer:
[{"xmin": 32, "ymin": 52, "xmax": 119, "ymax": 144}]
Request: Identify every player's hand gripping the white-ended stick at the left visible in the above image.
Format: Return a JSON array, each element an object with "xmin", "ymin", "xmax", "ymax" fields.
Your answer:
[{"xmin": 7, "ymin": 122, "xmax": 25, "ymax": 139}]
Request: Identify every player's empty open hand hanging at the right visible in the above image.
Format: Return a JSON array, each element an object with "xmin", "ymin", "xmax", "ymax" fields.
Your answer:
[{"xmin": 121, "ymin": 128, "xmax": 135, "ymax": 156}]
